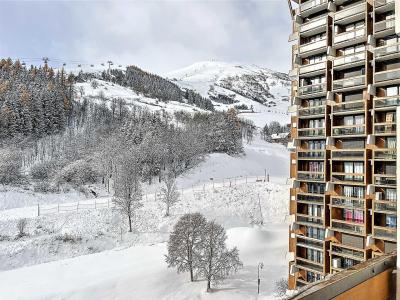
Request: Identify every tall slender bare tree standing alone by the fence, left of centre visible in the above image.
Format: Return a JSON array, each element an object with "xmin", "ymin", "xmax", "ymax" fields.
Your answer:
[{"xmin": 113, "ymin": 154, "xmax": 143, "ymax": 232}]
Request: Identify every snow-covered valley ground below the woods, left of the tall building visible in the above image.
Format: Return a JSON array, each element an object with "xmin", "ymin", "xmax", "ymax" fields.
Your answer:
[{"xmin": 0, "ymin": 138, "xmax": 289, "ymax": 299}]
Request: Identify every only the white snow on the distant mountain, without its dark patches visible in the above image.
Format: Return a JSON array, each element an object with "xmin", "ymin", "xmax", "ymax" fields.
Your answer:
[{"xmin": 166, "ymin": 61, "xmax": 290, "ymax": 127}]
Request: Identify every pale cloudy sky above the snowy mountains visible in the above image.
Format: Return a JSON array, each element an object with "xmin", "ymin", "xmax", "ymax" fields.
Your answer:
[{"xmin": 0, "ymin": 0, "xmax": 290, "ymax": 74}]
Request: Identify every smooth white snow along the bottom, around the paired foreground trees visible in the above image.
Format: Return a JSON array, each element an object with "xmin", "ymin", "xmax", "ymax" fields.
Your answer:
[{"xmin": 0, "ymin": 226, "xmax": 287, "ymax": 300}]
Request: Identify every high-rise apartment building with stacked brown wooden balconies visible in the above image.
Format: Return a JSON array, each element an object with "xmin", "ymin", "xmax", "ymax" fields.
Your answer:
[{"xmin": 288, "ymin": 0, "xmax": 400, "ymax": 289}]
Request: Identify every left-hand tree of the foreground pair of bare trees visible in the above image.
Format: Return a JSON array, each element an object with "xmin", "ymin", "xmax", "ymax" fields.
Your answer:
[{"xmin": 166, "ymin": 213, "xmax": 207, "ymax": 281}]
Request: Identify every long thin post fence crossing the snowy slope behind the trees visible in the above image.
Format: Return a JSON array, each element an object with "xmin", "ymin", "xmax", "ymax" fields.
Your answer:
[{"xmin": 37, "ymin": 174, "xmax": 276, "ymax": 216}]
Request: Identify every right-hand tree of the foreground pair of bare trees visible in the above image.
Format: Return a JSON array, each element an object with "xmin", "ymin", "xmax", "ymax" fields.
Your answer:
[{"xmin": 196, "ymin": 221, "xmax": 243, "ymax": 292}]
